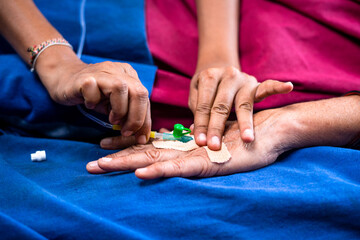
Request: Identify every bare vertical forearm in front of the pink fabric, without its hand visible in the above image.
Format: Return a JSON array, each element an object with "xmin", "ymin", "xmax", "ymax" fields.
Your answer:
[{"xmin": 196, "ymin": 0, "xmax": 240, "ymax": 70}]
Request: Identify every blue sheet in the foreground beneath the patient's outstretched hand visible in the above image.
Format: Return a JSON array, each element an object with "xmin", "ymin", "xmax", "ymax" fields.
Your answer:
[{"xmin": 0, "ymin": 134, "xmax": 360, "ymax": 239}]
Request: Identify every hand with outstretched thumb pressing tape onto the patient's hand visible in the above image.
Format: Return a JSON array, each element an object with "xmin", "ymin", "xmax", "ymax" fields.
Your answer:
[{"xmin": 189, "ymin": 67, "xmax": 293, "ymax": 150}]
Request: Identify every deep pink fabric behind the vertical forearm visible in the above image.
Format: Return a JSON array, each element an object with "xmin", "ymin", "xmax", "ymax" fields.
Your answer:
[{"xmin": 146, "ymin": 0, "xmax": 360, "ymax": 129}]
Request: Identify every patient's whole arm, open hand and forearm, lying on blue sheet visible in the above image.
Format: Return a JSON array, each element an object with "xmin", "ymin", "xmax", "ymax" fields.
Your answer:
[{"xmin": 87, "ymin": 96, "xmax": 360, "ymax": 179}]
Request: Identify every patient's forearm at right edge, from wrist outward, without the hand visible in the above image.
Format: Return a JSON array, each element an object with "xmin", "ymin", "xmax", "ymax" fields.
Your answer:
[{"xmin": 284, "ymin": 96, "xmax": 360, "ymax": 148}]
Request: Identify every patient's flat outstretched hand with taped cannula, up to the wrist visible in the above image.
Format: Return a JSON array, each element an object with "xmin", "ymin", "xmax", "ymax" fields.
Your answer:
[{"xmin": 87, "ymin": 110, "xmax": 292, "ymax": 179}]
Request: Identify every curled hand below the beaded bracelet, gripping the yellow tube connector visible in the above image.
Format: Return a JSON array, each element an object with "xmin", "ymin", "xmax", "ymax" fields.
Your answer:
[{"xmin": 36, "ymin": 47, "xmax": 151, "ymax": 144}]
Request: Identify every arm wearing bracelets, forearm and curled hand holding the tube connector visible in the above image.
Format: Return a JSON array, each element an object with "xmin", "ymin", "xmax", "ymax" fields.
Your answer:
[{"xmin": 0, "ymin": 0, "xmax": 151, "ymax": 143}]
